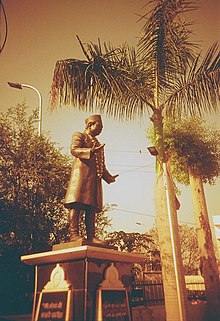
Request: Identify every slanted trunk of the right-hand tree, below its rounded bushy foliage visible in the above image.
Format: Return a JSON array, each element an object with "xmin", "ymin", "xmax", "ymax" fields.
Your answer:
[{"xmin": 189, "ymin": 168, "xmax": 220, "ymax": 321}]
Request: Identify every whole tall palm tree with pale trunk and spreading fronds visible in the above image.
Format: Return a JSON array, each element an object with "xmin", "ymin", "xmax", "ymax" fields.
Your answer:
[{"xmin": 51, "ymin": 0, "xmax": 220, "ymax": 321}]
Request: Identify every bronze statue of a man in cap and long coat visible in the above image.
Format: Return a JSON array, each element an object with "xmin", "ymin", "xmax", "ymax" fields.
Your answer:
[{"xmin": 64, "ymin": 115, "xmax": 118, "ymax": 243}]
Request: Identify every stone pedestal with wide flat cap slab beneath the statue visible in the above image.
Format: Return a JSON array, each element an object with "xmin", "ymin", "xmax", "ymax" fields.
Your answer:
[{"xmin": 21, "ymin": 245, "xmax": 145, "ymax": 321}]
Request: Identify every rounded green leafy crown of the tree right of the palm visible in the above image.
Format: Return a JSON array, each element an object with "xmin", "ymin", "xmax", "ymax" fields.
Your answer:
[{"xmin": 164, "ymin": 117, "xmax": 220, "ymax": 184}]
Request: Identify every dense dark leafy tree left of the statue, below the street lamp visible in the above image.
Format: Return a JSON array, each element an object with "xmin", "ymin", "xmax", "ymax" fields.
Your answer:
[{"xmin": 0, "ymin": 103, "xmax": 70, "ymax": 254}]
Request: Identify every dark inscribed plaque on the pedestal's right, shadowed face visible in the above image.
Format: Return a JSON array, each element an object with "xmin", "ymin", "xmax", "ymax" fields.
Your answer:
[{"xmin": 96, "ymin": 289, "xmax": 131, "ymax": 321}]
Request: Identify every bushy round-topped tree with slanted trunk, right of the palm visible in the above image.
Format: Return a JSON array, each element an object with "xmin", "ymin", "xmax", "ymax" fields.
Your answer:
[{"xmin": 161, "ymin": 117, "xmax": 220, "ymax": 315}]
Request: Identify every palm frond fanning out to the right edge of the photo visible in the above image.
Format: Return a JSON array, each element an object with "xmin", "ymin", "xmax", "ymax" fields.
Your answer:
[{"xmin": 161, "ymin": 43, "xmax": 220, "ymax": 117}]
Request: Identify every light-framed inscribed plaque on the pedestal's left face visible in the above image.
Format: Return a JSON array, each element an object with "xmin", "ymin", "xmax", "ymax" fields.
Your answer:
[{"xmin": 34, "ymin": 290, "xmax": 71, "ymax": 321}]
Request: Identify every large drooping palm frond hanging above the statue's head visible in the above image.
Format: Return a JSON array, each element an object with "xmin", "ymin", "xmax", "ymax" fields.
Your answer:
[{"xmin": 51, "ymin": 39, "xmax": 155, "ymax": 118}]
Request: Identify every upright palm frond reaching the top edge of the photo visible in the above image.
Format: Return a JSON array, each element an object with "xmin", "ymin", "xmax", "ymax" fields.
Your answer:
[{"xmin": 138, "ymin": 0, "xmax": 196, "ymax": 91}]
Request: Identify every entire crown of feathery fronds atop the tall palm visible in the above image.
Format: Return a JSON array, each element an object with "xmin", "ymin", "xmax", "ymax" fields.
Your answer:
[{"xmin": 50, "ymin": 0, "xmax": 220, "ymax": 119}]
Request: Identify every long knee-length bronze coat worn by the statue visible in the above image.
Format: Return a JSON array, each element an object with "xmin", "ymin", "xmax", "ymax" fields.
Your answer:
[{"xmin": 64, "ymin": 132, "xmax": 113, "ymax": 212}]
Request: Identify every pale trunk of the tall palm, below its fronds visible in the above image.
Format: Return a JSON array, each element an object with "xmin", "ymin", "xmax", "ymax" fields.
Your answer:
[{"xmin": 151, "ymin": 110, "xmax": 189, "ymax": 321}]
